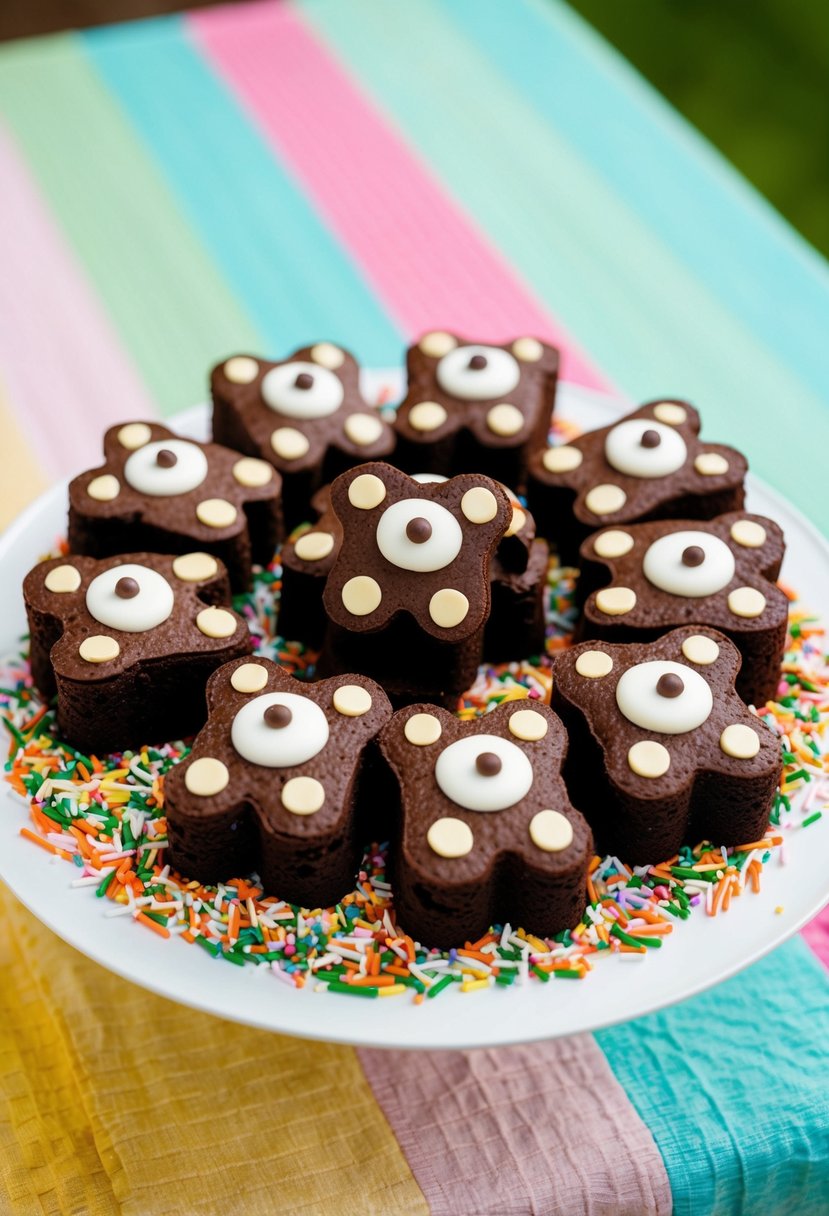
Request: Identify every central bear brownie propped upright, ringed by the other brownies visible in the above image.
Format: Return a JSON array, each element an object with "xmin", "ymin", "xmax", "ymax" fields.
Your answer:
[{"xmin": 318, "ymin": 463, "xmax": 513, "ymax": 705}]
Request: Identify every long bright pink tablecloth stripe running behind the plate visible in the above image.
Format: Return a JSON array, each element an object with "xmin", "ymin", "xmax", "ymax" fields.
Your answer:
[{"xmin": 186, "ymin": 4, "xmax": 607, "ymax": 388}]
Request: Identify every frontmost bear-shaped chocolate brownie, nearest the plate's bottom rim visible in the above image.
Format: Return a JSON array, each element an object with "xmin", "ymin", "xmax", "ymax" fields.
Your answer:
[{"xmin": 380, "ymin": 702, "xmax": 593, "ymax": 947}]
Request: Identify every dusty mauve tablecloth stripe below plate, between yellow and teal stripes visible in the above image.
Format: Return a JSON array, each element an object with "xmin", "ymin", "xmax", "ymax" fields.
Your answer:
[{"xmin": 359, "ymin": 1035, "xmax": 672, "ymax": 1216}]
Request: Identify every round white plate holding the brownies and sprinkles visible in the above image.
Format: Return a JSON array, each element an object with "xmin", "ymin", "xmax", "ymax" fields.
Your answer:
[{"xmin": 0, "ymin": 384, "xmax": 829, "ymax": 1048}]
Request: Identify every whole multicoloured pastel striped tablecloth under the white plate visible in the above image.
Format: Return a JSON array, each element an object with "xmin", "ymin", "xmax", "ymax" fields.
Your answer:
[{"xmin": 0, "ymin": 0, "xmax": 829, "ymax": 1216}]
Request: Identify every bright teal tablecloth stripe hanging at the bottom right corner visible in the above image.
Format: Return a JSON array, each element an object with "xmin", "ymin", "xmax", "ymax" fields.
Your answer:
[{"xmin": 596, "ymin": 939, "xmax": 829, "ymax": 1216}]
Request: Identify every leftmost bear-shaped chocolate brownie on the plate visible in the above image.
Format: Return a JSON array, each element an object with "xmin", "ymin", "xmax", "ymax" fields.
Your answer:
[{"xmin": 23, "ymin": 553, "xmax": 250, "ymax": 755}]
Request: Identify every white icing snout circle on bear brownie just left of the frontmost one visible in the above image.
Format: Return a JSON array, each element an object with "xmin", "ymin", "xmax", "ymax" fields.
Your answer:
[{"xmin": 230, "ymin": 692, "xmax": 328, "ymax": 769}]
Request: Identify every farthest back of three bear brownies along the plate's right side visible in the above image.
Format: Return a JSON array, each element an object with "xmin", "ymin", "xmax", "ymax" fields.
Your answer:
[{"xmin": 528, "ymin": 400, "xmax": 748, "ymax": 564}]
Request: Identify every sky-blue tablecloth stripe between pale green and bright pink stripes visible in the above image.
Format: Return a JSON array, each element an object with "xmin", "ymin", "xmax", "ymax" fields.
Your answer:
[{"xmin": 84, "ymin": 17, "xmax": 404, "ymax": 366}]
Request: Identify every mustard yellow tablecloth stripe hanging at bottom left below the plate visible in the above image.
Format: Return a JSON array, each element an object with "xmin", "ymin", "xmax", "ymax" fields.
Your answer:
[{"xmin": 0, "ymin": 894, "xmax": 428, "ymax": 1216}]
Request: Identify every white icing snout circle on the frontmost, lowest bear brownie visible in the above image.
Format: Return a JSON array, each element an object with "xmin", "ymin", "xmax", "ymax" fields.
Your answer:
[{"xmin": 435, "ymin": 734, "xmax": 534, "ymax": 811}]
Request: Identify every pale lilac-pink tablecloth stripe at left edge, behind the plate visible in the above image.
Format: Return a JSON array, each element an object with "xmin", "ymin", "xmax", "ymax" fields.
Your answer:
[{"xmin": 0, "ymin": 125, "xmax": 156, "ymax": 475}]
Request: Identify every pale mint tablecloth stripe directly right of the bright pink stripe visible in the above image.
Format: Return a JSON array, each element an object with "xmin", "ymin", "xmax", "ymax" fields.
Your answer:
[{"xmin": 301, "ymin": 0, "xmax": 829, "ymax": 532}]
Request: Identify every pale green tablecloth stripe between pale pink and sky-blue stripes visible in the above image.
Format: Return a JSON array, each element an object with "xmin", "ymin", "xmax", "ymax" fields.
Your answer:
[{"xmin": 0, "ymin": 35, "xmax": 261, "ymax": 413}]
